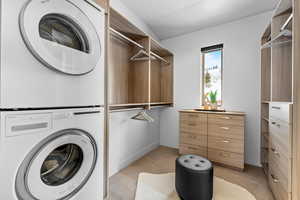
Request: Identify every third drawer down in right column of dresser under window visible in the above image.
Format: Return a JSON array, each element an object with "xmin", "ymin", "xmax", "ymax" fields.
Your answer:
[{"xmin": 208, "ymin": 136, "xmax": 244, "ymax": 154}]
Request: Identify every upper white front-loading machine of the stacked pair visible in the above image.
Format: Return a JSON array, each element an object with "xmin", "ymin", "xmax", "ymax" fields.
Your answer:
[{"xmin": 0, "ymin": 0, "xmax": 105, "ymax": 108}]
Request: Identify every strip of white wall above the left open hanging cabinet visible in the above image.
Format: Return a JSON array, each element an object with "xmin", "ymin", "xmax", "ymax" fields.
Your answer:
[{"xmin": 110, "ymin": 0, "xmax": 159, "ymax": 41}]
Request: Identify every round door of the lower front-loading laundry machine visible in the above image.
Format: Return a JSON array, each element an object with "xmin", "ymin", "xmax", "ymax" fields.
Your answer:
[{"xmin": 16, "ymin": 129, "xmax": 97, "ymax": 200}]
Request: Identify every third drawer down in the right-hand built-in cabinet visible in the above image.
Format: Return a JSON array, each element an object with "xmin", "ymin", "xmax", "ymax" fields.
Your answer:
[{"xmin": 269, "ymin": 138, "xmax": 292, "ymax": 180}]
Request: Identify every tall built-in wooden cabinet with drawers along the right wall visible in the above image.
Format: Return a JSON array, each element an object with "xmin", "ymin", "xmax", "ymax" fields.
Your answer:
[{"xmin": 261, "ymin": 0, "xmax": 295, "ymax": 200}]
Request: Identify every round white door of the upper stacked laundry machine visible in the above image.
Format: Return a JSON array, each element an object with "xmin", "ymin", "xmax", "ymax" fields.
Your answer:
[{"xmin": 19, "ymin": 0, "xmax": 101, "ymax": 75}]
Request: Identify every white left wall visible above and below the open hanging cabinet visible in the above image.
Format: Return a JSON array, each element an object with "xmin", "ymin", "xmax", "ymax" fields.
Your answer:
[{"xmin": 109, "ymin": 0, "xmax": 160, "ymax": 176}]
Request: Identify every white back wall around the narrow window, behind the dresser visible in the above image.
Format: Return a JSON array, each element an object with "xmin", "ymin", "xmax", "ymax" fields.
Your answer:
[{"xmin": 160, "ymin": 12, "xmax": 271, "ymax": 166}]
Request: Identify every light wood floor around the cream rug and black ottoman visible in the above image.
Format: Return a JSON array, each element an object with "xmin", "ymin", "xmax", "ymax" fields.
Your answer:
[{"xmin": 109, "ymin": 147, "xmax": 274, "ymax": 200}]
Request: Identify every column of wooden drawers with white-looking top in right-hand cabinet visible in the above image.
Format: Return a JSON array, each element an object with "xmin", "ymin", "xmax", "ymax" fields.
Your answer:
[{"xmin": 268, "ymin": 102, "xmax": 293, "ymax": 200}]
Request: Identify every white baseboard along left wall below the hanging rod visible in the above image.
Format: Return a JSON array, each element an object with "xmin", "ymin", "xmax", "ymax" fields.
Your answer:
[{"xmin": 109, "ymin": 143, "xmax": 160, "ymax": 176}]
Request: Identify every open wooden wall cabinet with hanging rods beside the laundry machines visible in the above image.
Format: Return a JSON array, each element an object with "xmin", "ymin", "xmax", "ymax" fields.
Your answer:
[{"xmin": 108, "ymin": 8, "xmax": 173, "ymax": 109}]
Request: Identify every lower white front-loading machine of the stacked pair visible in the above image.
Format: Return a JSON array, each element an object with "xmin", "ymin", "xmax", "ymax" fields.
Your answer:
[{"xmin": 0, "ymin": 108, "xmax": 104, "ymax": 200}]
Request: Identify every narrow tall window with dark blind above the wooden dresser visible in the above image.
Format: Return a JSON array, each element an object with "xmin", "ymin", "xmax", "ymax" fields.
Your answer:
[{"xmin": 201, "ymin": 44, "xmax": 223, "ymax": 106}]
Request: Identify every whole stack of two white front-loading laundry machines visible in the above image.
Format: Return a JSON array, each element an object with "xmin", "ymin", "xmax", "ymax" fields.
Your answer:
[{"xmin": 0, "ymin": 0, "xmax": 105, "ymax": 200}]
